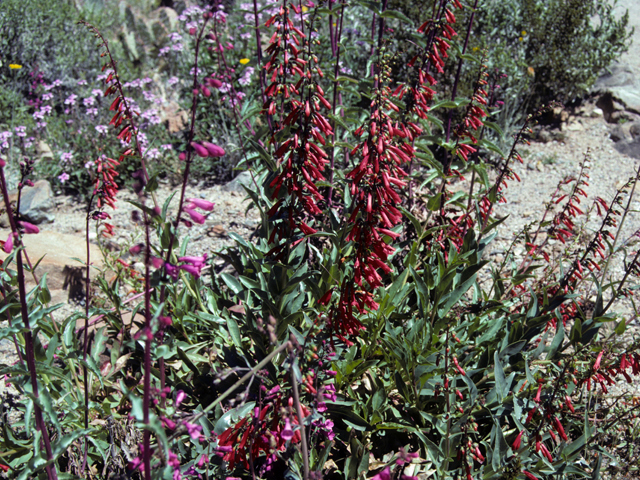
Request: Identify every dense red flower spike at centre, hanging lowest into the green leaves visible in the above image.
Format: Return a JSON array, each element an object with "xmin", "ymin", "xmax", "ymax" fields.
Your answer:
[{"xmin": 330, "ymin": 62, "xmax": 422, "ymax": 339}]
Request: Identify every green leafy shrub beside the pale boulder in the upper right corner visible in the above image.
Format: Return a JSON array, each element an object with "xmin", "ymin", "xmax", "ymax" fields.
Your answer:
[{"xmin": 472, "ymin": 0, "xmax": 633, "ymax": 131}]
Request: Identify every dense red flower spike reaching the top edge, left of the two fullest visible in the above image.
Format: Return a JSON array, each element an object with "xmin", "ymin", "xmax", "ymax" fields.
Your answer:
[{"xmin": 264, "ymin": 0, "xmax": 333, "ymax": 243}]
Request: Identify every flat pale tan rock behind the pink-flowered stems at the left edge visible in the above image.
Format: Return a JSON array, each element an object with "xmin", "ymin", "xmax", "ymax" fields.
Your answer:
[{"xmin": 0, "ymin": 229, "xmax": 102, "ymax": 299}]
